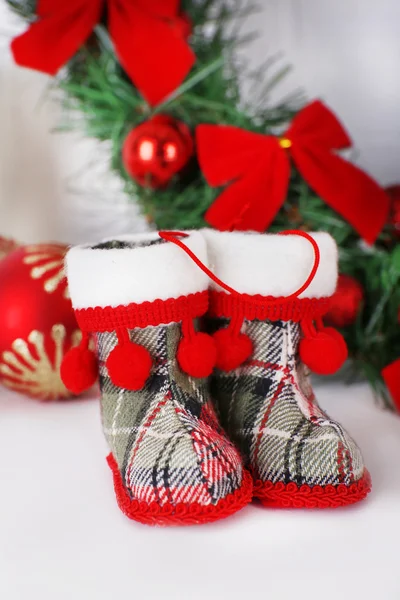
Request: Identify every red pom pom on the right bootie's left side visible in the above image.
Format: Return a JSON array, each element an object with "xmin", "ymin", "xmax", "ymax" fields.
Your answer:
[{"xmin": 214, "ymin": 328, "xmax": 253, "ymax": 371}]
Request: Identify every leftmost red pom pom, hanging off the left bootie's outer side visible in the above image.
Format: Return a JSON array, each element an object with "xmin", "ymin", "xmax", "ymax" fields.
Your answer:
[{"xmin": 60, "ymin": 346, "xmax": 98, "ymax": 395}]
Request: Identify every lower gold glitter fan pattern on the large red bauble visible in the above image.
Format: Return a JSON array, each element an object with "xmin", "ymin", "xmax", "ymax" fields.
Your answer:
[{"xmin": 0, "ymin": 324, "xmax": 82, "ymax": 401}]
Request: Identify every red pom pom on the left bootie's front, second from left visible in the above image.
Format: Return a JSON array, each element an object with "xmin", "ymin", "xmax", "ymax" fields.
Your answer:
[{"xmin": 106, "ymin": 343, "xmax": 153, "ymax": 392}]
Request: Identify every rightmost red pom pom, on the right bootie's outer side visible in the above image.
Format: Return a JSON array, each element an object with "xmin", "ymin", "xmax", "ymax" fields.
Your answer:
[{"xmin": 300, "ymin": 327, "xmax": 348, "ymax": 375}]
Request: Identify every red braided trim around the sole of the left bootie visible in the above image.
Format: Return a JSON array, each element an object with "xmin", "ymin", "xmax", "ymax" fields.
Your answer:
[{"xmin": 107, "ymin": 454, "xmax": 253, "ymax": 525}]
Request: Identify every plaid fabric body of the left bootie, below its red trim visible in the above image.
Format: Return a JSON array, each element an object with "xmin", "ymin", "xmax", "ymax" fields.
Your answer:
[{"xmin": 97, "ymin": 323, "xmax": 243, "ymax": 506}]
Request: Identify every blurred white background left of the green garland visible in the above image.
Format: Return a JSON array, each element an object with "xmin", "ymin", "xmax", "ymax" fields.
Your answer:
[{"xmin": 0, "ymin": 0, "xmax": 145, "ymax": 243}]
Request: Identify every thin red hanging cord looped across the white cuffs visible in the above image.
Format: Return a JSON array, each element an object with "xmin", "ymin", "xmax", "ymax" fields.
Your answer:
[{"xmin": 158, "ymin": 229, "xmax": 321, "ymax": 304}]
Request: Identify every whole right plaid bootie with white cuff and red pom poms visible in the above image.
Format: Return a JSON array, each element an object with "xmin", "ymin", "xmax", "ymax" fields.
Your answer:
[{"xmin": 205, "ymin": 231, "xmax": 370, "ymax": 508}]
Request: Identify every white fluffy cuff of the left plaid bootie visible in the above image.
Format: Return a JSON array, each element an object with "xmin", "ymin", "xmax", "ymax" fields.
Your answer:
[{"xmin": 66, "ymin": 232, "xmax": 209, "ymax": 309}]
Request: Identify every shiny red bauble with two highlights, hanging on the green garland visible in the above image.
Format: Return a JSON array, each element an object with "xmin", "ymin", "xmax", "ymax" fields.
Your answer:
[{"xmin": 122, "ymin": 115, "xmax": 194, "ymax": 189}]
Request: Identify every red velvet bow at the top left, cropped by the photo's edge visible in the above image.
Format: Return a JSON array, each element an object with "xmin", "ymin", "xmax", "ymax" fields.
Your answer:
[{"xmin": 11, "ymin": 0, "xmax": 195, "ymax": 106}]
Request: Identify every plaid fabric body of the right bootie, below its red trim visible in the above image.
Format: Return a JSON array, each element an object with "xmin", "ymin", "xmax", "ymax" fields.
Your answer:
[{"xmin": 211, "ymin": 320, "xmax": 364, "ymax": 486}]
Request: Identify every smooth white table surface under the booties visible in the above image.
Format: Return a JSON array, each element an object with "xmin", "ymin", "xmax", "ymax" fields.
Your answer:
[{"xmin": 0, "ymin": 384, "xmax": 400, "ymax": 600}]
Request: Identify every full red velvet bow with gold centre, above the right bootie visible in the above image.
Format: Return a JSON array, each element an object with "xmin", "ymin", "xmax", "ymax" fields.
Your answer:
[{"xmin": 197, "ymin": 101, "xmax": 389, "ymax": 243}]
